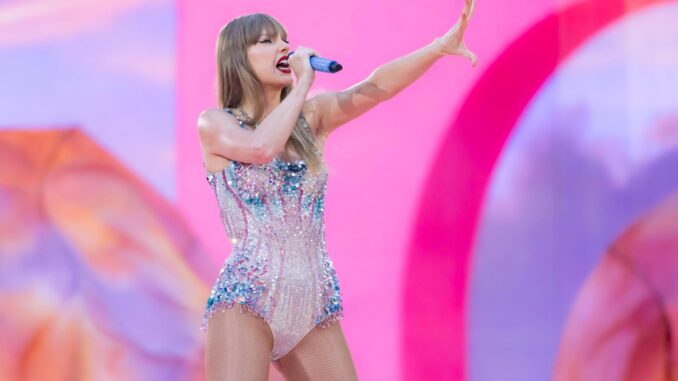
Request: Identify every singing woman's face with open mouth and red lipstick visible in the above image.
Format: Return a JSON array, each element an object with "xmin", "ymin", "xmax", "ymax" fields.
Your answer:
[{"xmin": 247, "ymin": 32, "xmax": 293, "ymax": 88}]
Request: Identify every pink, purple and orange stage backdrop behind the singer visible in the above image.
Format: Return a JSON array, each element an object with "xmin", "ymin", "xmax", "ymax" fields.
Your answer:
[{"xmin": 0, "ymin": 0, "xmax": 678, "ymax": 381}]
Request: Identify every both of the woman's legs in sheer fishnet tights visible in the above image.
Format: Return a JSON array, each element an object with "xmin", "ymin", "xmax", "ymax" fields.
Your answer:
[{"xmin": 205, "ymin": 307, "xmax": 358, "ymax": 381}]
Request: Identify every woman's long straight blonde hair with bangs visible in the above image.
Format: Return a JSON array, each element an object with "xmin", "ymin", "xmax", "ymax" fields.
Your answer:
[{"xmin": 216, "ymin": 13, "xmax": 322, "ymax": 170}]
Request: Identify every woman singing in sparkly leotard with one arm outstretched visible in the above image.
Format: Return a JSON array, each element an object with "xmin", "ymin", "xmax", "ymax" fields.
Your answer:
[{"xmin": 198, "ymin": 0, "xmax": 476, "ymax": 381}]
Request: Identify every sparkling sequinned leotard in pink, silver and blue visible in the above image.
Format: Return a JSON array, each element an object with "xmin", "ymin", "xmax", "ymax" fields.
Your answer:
[{"xmin": 201, "ymin": 109, "xmax": 343, "ymax": 360}]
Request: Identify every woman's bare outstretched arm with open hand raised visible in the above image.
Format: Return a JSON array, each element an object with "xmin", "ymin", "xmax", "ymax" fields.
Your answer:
[{"xmin": 308, "ymin": 0, "xmax": 477, "ymax": 135}]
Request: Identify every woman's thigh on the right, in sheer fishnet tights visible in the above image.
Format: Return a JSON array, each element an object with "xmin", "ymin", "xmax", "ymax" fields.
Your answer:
[{"xmin": 274, "ymin": 322, "xmax": 358, "ymax": 381}]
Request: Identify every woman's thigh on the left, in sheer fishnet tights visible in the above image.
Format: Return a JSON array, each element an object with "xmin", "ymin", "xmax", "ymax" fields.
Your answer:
[{"xmin": 205, "ymin": 306, "xmax": 273, "ymax": 381}]
